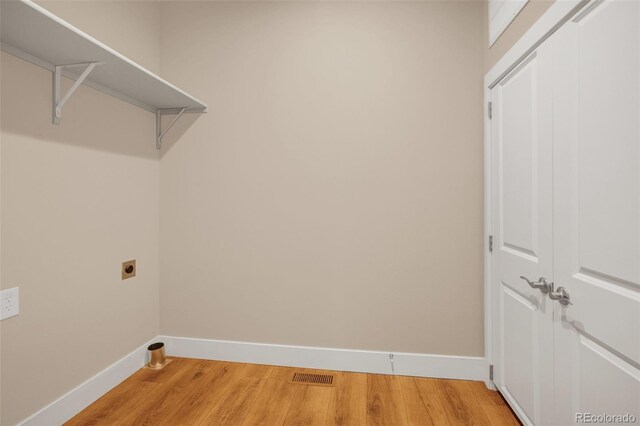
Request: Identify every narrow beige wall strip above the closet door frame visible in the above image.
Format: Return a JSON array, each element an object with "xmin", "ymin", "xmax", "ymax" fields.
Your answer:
[{"xmin": 483, "ymin": 0, "xmax": 554, "ymax": 72}]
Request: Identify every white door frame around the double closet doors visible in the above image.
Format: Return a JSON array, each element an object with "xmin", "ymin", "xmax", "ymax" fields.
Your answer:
[{"xmin": 483, "ymin": 0, "xmax": 592, "ymax": 390}]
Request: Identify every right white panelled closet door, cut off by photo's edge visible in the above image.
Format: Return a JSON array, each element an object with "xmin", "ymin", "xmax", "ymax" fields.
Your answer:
[{"xmin": 553, "ymin": 0, "xmax": 640, "ymax": 425}]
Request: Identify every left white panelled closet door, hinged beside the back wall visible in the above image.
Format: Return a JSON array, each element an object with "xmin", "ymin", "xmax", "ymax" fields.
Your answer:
[{"xmin": 491, "ymin": 39, "xmax": 553, "ymax": 424}]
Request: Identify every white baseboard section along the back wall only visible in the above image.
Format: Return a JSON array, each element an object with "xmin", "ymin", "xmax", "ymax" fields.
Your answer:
[{"xmin": 158, "ymin": 336, "xmax": 489, "ymax": 383}]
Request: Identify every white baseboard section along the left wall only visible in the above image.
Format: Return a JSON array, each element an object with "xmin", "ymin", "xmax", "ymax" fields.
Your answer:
[{"xmin": 18, "ymin": 339, "xmax": 157, "ymax": 426}]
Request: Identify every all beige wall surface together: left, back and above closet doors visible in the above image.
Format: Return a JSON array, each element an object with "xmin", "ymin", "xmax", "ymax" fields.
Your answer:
[{"xmin": 0, "ymin": 0, "xmax": 551, "ymax": 425}]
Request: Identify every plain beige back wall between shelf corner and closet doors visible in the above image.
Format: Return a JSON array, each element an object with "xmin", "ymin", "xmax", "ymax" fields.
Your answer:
[{"xmin": 160, "ymin": 2, "xmax": 485, "ymax": 356}]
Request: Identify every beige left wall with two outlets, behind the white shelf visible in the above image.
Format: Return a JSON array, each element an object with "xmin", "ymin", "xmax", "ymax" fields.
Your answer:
[{"xmin": 0, "ymin": 4, "xmax": 159, "ymax": 426}]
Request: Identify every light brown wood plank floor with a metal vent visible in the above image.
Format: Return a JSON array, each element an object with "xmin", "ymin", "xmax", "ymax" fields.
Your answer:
[{"xmin": 66, "ymin": 358, "xmax": 520, "ymax": 426}]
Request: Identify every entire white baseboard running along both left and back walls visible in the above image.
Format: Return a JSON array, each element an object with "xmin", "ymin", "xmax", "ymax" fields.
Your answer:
[{"xmin": 19, "ymin": 336, "xmax": 489, "ymax": 426}]
